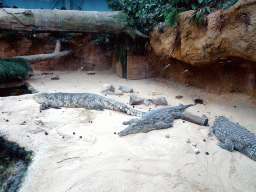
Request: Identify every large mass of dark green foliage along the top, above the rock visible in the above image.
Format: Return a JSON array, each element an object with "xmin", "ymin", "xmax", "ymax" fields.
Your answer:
[{"xmin": 106, "ymin": 0, "xmax": 237, "ymax": 30}]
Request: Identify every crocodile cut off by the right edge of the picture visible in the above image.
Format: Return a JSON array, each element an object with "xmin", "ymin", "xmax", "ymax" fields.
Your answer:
[{"xmin": 208, "ymin": 116, "xmax": 256, "ymax": 161}]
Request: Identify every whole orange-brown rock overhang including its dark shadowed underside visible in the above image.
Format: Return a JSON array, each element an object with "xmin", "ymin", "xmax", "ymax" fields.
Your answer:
[{"xmin": 149, "ymin": 0, "xmax": 256, "ymax": 94}]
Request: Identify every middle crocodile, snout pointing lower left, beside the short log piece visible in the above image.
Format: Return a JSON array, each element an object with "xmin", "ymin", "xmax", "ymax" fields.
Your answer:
[{"xmin": 118, "ymin": 104, "xmax": 195, "ymax": 136}]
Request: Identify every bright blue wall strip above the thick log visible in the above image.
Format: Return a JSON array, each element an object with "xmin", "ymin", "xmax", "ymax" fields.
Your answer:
[{"xmin": 0, "ymin": 0, "xmax": 111, "ymax": 11}]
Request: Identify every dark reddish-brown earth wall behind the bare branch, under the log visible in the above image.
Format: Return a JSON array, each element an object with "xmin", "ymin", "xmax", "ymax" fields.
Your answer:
[{"xmin": 0, "ymin": 33, "xmax": 113, "ymax": 71}]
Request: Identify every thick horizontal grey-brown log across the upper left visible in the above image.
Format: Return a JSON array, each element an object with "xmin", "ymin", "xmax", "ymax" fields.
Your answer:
[{"xmin": 0, "ymin": 8, "xmax": 125, "ymax": 33}]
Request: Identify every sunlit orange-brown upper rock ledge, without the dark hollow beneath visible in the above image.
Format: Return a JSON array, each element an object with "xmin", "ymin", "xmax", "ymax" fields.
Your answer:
[{"xmin": 151, "ymin": 0, "xmax": 256, "ymax": 65}]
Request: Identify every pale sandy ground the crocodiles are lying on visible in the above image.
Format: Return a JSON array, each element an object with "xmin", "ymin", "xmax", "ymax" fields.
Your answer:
[{"xmin": 0, "ymin": 72, "xmax": 256, "ymax": 192}]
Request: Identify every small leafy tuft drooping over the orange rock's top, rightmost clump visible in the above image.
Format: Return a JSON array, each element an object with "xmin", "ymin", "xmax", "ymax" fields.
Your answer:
[{"xmin": 189, "ymin": 7, "xmax": 211, "ymax": 25}]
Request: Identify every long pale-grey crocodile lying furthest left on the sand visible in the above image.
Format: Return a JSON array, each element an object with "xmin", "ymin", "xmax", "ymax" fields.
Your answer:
[{"xmin": 34, "ymin": 93, "xmax": 145, "ymax": 117}]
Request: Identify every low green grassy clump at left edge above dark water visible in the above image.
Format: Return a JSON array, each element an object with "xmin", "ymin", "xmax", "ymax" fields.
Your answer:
[{"xmin": 0, "ymin": 59, "xmax": 32, "ymax": 82}]
